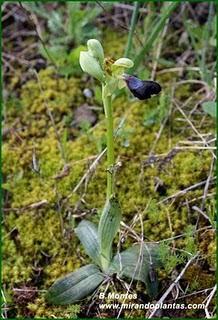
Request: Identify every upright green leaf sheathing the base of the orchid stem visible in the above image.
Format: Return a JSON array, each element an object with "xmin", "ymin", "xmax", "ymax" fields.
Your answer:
[{"xmin": 98, "ymin": 197, "xmax": 121, "ymax": 270}]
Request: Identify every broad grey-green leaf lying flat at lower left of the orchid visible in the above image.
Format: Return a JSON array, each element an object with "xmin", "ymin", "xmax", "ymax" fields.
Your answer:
[{"xmin": 46, "ymin": 264, "xmax": 104, "ymax": 305}]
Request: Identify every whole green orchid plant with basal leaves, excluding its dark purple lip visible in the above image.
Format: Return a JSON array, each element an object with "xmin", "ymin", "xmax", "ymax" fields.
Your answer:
[{"xmin": 46, "ymin": 39, "xmax": 160, "ymax": 305}]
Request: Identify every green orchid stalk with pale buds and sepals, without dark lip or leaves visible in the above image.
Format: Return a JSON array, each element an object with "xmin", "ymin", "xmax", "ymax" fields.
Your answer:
[{"xmin": 80, "ymin": 39, "xmax": 133, "ymax": 199}]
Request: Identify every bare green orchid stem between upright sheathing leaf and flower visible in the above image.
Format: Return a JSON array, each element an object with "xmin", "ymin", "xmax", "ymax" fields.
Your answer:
[{"xmin": 102, "ymin": 86, "xmax": 114, "ymax": 199}]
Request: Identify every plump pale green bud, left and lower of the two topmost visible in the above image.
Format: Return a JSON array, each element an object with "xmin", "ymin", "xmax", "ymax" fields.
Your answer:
[{"xmin": 79, "ymin": 51, "xmax": 104, "ymax": 82}]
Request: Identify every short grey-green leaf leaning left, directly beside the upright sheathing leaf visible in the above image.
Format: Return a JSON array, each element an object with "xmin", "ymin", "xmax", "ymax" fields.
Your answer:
[{"xmin": 75, "ymin": 220, "xmax": 101, "ymax": 266}]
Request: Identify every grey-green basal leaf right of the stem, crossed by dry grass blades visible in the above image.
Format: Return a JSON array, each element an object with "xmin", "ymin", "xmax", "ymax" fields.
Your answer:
[{"xmin": 109, "ymin": 243, "xmax": 161, "ymax": 297}]
